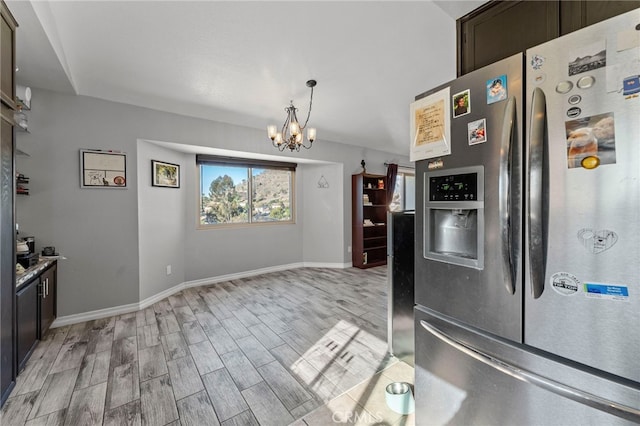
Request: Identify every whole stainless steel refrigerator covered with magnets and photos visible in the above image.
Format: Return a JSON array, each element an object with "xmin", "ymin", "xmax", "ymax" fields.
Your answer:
[{"xmin": 414, "ymin": 9, "xmax": 640, "ymax": 425}]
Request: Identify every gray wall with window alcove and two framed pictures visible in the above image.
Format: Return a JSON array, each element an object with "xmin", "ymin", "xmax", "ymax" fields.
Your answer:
[{"xmin": 16, "ymin": 89, "xmax": 408, "ymax": 316}]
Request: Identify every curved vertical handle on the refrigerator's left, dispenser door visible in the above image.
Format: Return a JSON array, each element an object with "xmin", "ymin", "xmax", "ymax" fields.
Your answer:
[{"xmin": 498, "ymin": 96, "xmax": 517, "ymax": 294}]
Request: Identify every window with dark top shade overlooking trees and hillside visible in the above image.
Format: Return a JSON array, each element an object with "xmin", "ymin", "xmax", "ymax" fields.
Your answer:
[{"xmin": 196, "ymin": 155, "xmax": 296, "ymax": 227}]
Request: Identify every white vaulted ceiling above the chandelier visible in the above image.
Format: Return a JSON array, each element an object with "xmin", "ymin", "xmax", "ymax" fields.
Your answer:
[{"xmin": 7, "ymin": 0, "xmax": 484, "ymax": 155}]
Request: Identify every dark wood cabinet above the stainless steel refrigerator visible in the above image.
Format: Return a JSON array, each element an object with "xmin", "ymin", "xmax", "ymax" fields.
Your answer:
[{"xmin": 457, "ymin": 0, "xmax": 640, "ymax": 76}]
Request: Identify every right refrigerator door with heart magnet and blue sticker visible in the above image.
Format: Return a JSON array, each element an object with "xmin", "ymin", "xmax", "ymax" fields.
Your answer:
[{"xmin": 524, "ymin": 9, "xmax": 640, "ymax": 384}]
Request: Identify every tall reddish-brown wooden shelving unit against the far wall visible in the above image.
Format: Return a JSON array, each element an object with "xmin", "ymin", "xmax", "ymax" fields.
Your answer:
[{"xmin": 351, "ymin": 173, "xmax": 388, "ymax": 268}]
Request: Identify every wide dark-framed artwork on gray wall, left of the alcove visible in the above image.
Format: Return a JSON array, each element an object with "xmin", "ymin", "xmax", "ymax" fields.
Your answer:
[{"xmin": 80, "ymin": 149, "xmax": 127, "ymax": 189}]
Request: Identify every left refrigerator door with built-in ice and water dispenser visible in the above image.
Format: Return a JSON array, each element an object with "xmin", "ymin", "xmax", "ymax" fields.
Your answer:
[{"xmin": 415, "ymin": 54, "xmax": 524, "ymax": 341}]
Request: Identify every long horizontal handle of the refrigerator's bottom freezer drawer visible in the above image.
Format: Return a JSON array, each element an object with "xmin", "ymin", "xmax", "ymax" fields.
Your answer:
[{"xmin": 420, "ymin": 320, "xmax": 640, "ymax": 421}]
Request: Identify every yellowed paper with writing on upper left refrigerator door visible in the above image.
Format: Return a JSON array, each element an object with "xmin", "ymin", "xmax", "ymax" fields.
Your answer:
[{"xmin": 409, "ymin": 87, "xmax": 451, "ymax": 161}]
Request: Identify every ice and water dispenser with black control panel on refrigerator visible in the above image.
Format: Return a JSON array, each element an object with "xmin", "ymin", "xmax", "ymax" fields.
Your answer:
[{"xmin": 424, "ymin": 166, "xmax": 484, "ymax": 269}]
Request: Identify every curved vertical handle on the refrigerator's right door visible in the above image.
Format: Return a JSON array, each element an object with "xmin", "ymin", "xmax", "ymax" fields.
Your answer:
[{"xmin": 527, "ymin": 87, "xmax": 548, "ymax": 299}]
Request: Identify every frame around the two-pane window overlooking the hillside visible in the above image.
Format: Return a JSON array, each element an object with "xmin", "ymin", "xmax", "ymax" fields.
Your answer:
[{"xmin": 196, "ymin": 154, "xmax": 297, "ymax": 230}]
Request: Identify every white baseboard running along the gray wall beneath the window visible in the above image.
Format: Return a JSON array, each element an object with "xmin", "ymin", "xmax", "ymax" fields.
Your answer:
[{"xmin": 51, "ymin": 262, "xmax": 351, "ymax": 328}]
